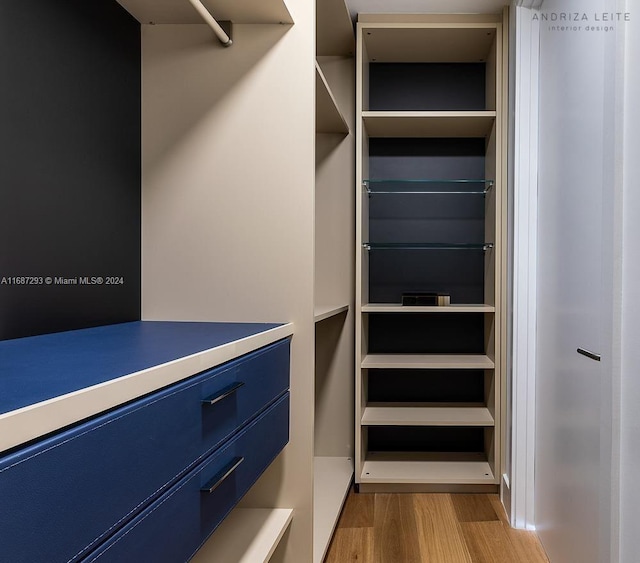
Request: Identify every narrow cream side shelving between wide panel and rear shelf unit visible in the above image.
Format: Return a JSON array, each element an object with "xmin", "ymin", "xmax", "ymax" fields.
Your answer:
[{"xmin": 313, "ymin": 0, "xmax": 355, "ymax": 563}]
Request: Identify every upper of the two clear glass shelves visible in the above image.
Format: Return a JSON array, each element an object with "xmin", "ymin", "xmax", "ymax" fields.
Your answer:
[{"xmin": 362, "ymin": 183, "xmax": 494, "ymax": 196}]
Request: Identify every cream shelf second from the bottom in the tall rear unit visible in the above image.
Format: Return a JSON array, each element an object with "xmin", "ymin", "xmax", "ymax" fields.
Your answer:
[{"xmin": 362, "ymin": 406, "xmax": 495, "ymax": 426}]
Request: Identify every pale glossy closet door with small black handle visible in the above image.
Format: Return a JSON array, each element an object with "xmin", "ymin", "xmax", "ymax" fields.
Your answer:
[{"xmin": 535, "ymin": 2, "xmax": 614, "ymax": 563}]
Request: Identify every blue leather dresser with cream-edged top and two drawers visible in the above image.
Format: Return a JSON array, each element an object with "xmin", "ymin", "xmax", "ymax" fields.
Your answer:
[{"xmin": 0, "ymin": 322, "xmax": 290, "ymax": 563}]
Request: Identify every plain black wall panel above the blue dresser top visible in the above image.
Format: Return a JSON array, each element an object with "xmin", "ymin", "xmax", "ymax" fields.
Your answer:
[{"xmin": 0, "ymin": 0, "xmax": 141, "ymax": 340}]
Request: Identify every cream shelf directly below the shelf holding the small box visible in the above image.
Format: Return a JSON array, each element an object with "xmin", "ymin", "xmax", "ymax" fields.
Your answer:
[{"xmin": 362, "ymin": 354, "xmax": 495, "ymax": 369}]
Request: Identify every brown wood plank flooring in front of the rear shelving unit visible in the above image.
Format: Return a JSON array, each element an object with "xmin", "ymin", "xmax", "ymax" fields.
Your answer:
[{"xmin": 325, "ymin": 490, "xmax": 549, "ymax": 563}]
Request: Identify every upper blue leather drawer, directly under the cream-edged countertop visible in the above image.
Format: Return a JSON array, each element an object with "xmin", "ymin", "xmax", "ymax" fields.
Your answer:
[{"xmin": 0, "ymin": 340, "xmax": 289, "ymax": 563}]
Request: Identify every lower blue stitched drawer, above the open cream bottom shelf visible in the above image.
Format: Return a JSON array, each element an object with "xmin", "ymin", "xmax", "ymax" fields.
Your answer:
[{"xmin": 83, "ymin": 393, "xmax": 289, "ymax": 563}]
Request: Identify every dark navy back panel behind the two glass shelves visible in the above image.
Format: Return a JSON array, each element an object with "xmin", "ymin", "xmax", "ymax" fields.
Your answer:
[{"xmin": 369, "ymin": 138, "xmax": 485, "ymax": 304}]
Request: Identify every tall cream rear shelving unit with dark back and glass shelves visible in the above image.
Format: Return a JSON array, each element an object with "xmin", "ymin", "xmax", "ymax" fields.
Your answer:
[{"xmin": 355, "ymin": 14, "xmax": 506, "ymax": 492}]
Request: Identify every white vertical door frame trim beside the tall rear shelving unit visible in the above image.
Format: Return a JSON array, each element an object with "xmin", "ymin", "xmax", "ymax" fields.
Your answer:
[{"xmin": 506, "ymin": 0, "xmax": 540, "ymax": 528}]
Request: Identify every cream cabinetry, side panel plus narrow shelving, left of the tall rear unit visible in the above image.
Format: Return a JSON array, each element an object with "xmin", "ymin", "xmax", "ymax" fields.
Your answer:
[{"xmin": 122, "ymin": 0, "xmax": 355, "ymax": 563}]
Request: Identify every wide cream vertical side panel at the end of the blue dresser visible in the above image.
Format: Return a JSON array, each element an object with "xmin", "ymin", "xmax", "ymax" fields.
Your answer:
[{"xmin": 143, "ymin": 5, "xmax": 315, "ymax": 563}]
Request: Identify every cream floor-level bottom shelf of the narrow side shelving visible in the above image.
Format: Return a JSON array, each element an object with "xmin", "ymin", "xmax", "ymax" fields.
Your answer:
[{"xmin": 313, "ymin": 456, "xmax": 353, "ymax": 563}]
